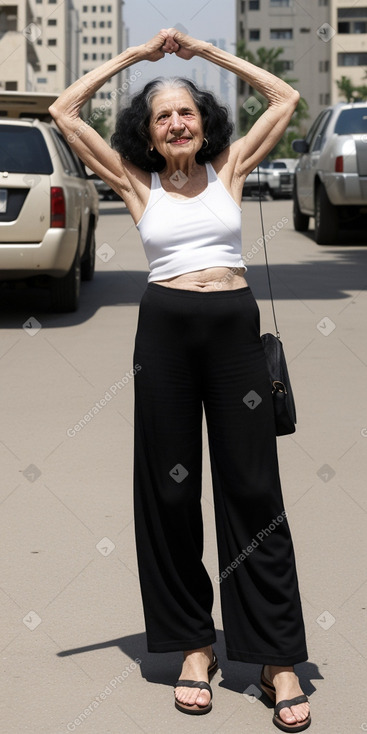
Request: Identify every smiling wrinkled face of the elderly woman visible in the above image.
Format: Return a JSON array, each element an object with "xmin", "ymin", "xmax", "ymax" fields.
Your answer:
[{"xmin": 149, "ymin": 87, "xmax": 204, "ymax": 165}]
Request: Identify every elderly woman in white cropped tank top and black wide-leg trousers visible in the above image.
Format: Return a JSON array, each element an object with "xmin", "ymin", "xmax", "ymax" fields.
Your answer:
[{"xmin": 50, "ymin": 28, "xmax": 311, "ymax": 732}]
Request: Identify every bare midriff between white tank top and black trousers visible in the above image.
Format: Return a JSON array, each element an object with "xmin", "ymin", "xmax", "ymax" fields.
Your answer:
[{"xmin": 154, "ymin": 267, "xmax": 247, "ymax": 291}]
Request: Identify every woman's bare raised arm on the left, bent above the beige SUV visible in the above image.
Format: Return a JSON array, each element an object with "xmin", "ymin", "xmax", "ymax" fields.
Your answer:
[{"xmin": 49, "ymin": 31, "xmax": 167, "ymax": 203}]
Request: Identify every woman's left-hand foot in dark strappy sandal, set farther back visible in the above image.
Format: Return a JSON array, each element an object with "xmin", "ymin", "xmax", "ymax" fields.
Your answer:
[{"xmin": 175, "ymin": 645, "xmax": 213, "ymax": 706}]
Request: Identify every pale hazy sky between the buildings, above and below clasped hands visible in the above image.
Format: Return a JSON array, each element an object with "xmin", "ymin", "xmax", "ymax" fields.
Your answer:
[{"xmin": 123, "ymin": 0, "xmax": 236, "ymax": 111}]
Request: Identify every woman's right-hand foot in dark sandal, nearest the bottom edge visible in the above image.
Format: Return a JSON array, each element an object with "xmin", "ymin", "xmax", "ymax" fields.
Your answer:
[{"xmin": 262, "ymin": 665, "xmax": 311, "ymax": 732}]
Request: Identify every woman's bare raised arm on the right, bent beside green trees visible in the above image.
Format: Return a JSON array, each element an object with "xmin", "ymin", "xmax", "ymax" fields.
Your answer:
[{"xmin": 169, "ymin": 28, "xmax": 300, "ymax": 178}]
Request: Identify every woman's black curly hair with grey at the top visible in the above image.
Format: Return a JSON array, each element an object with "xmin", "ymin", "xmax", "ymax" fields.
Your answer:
[{"xmin": 111, "ymin": 77, "xmax": 234, "ymax": 171}]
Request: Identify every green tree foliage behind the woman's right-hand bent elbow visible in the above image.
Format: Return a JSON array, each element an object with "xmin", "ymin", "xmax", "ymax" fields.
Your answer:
[{"xmin": 237, "ymin": 41, "xmax": 309, "ymax": 158}]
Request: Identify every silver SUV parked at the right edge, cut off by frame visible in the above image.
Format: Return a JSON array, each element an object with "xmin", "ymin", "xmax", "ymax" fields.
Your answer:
[{"xmin": 292, "ymin": 102, "xmax": 367, "ymax": 245}]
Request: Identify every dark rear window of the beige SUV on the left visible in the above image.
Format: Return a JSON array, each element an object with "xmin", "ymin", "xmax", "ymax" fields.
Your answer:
[{"xmin": 0, "ymin": 125, "xmax": 53, "ymax": 174}]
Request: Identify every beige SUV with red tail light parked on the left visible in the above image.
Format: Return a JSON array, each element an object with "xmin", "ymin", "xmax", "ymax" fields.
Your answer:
[{"xmin": 0, "ymin": 118, "xmax": 99, "ymax": 312}]
